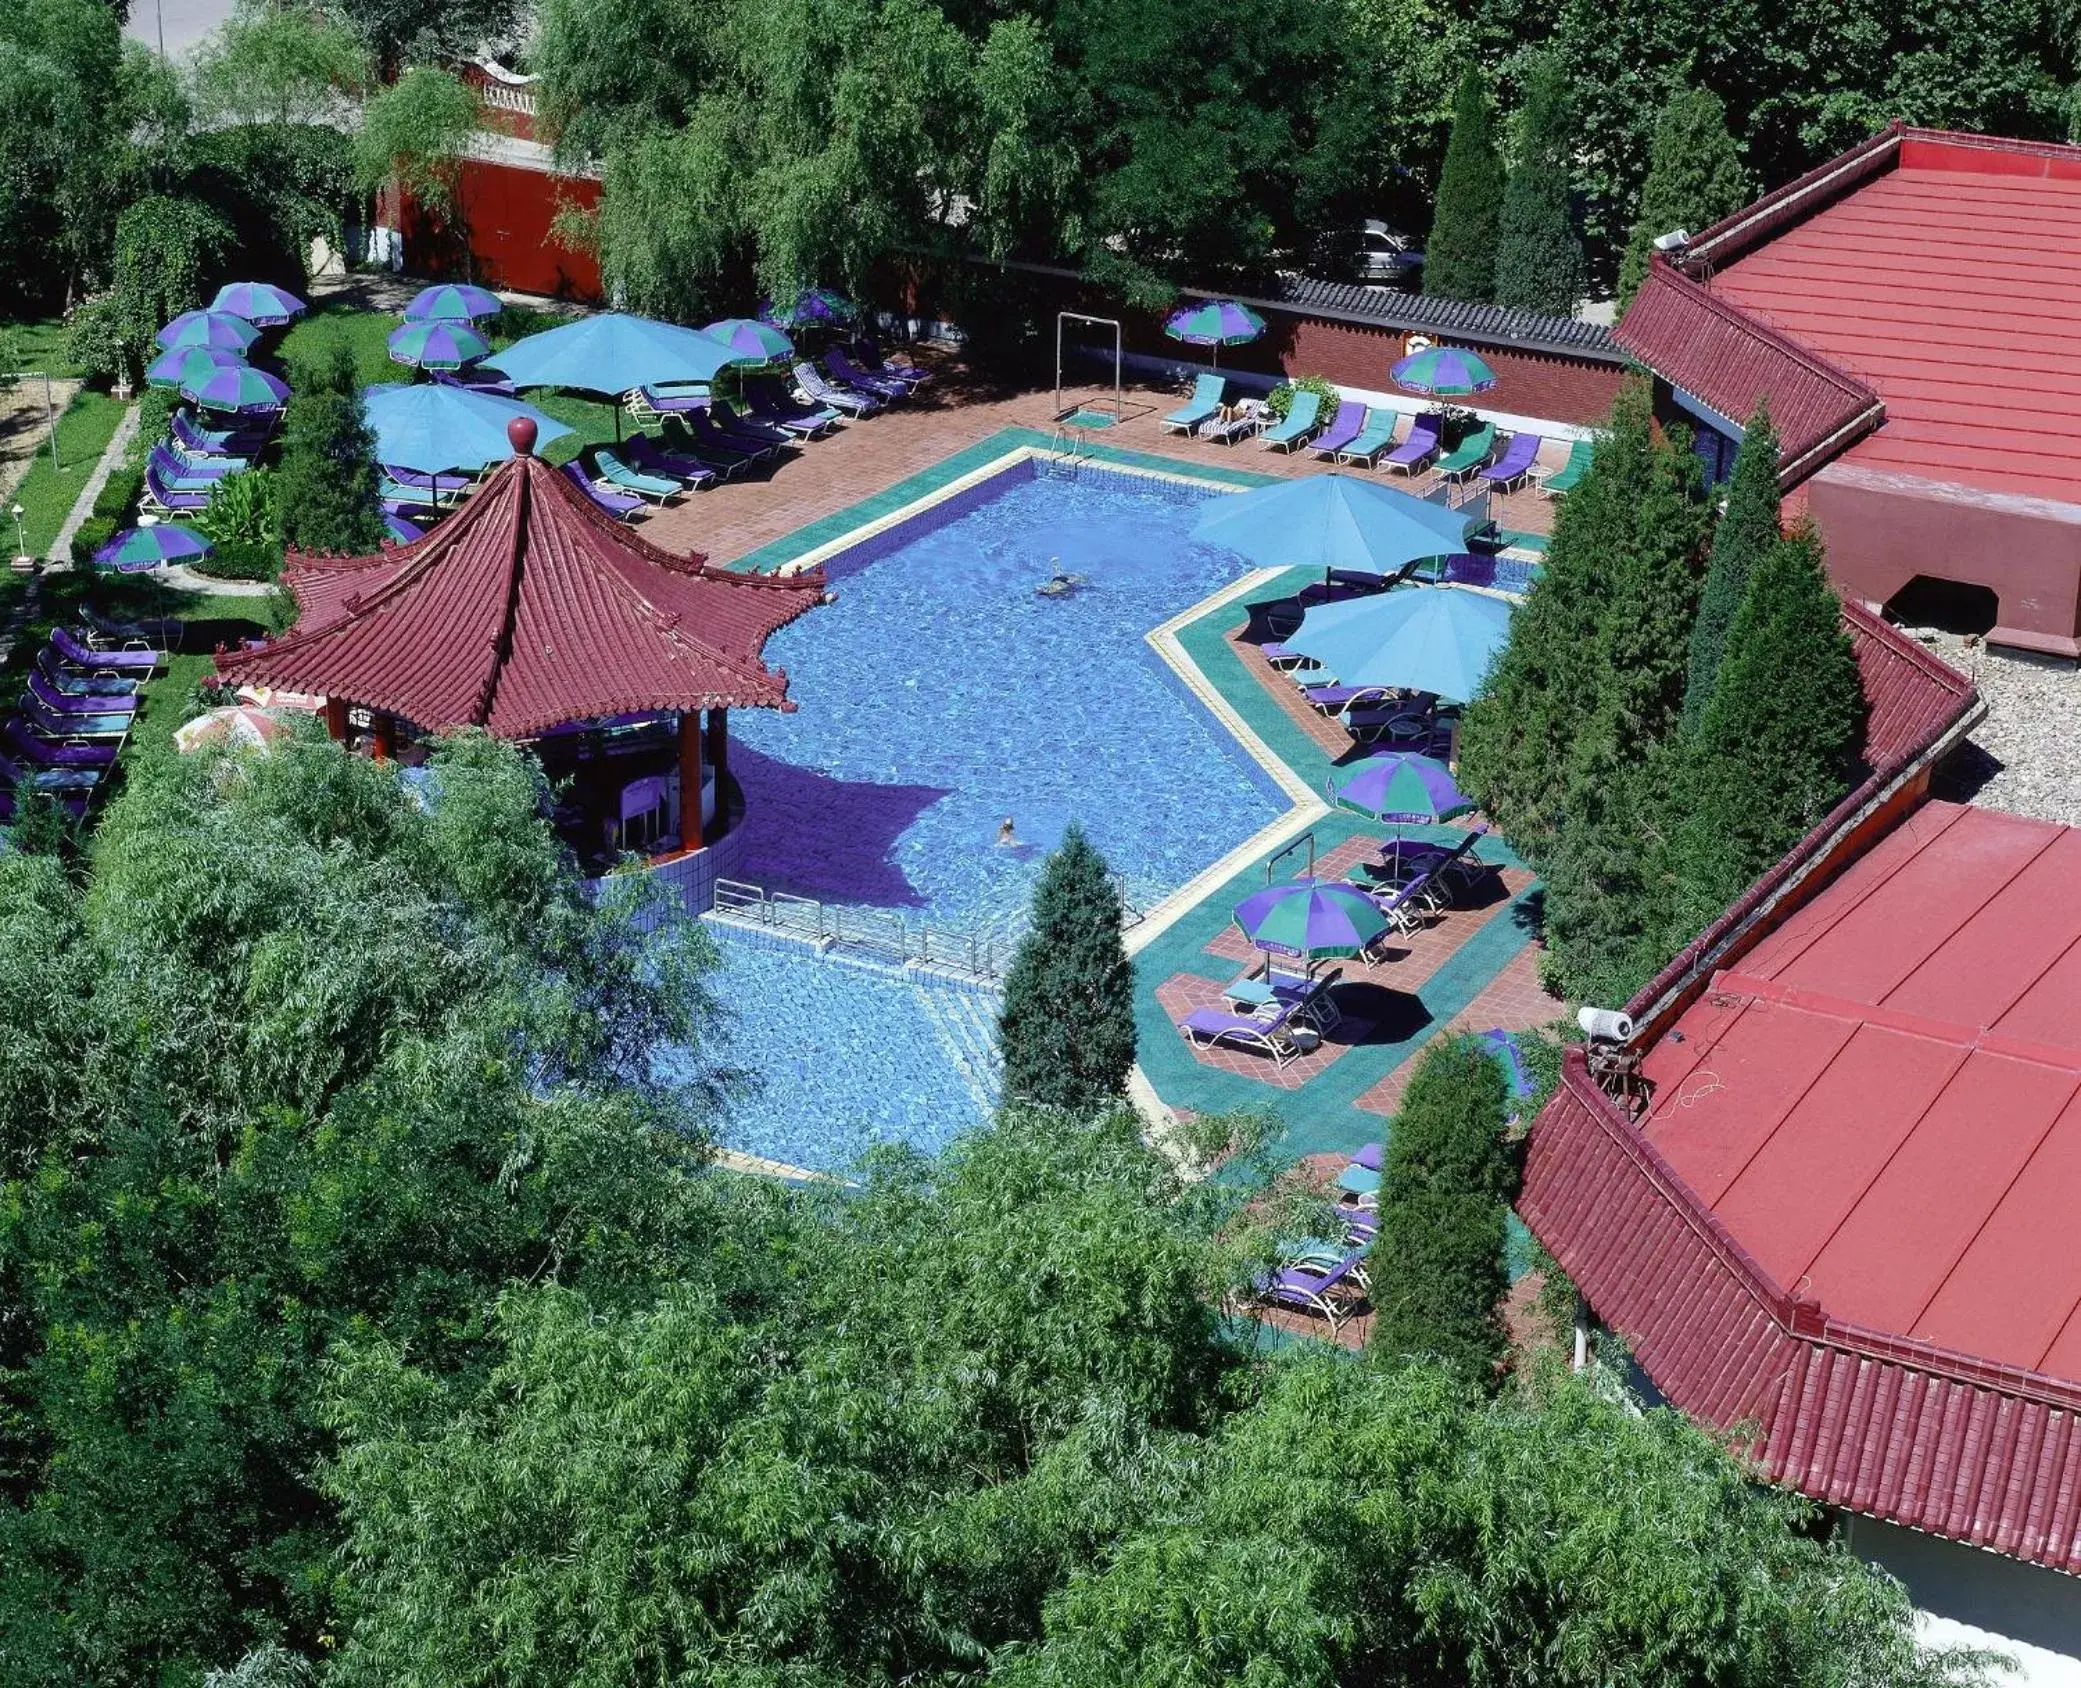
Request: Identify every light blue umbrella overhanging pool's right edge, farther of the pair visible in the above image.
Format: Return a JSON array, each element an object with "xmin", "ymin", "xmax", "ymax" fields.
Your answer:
[{"xmin": 1192, "ymin": 475, "xmax": 1473, "ymax": 582}]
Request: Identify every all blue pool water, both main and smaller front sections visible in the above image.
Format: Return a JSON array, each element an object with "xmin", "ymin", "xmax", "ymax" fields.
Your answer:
[{"xmin": 716, "ymin": 462, "xmax": 1286, "ymax": 1172}]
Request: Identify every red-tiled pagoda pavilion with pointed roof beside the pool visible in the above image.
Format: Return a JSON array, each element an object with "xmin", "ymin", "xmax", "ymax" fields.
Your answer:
[{"xmin": 216, "ymin": 420, "xmax": 824, "ymax": 853}]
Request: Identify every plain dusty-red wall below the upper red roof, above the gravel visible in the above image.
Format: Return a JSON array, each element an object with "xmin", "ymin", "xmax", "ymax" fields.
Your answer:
[{"xmin": 1802, "ymin": 460, "xmax": 2081, "ymax": 656}]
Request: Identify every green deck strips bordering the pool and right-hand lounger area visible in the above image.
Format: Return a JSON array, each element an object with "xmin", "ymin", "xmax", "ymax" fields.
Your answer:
[{"xmin": 728, "ymin": 427, "xmax": 1540, "ymax": 1159}]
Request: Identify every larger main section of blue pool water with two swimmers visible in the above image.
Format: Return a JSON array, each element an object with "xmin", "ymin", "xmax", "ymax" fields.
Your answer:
[{"xmin": 730, "ymin": 472, "xmax": 1284, "ymax": 926}]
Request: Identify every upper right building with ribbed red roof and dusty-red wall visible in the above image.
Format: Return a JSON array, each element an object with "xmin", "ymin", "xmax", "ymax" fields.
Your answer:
[{"xmin": 1617, "ymin": 127, "xmax": 2081, "ymax": 656}]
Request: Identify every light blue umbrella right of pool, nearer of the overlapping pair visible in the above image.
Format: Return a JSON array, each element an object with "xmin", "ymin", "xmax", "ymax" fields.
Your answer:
[{"xmin": 1286, "ymin": 587, "xmax": 1511, "ymax": 704}]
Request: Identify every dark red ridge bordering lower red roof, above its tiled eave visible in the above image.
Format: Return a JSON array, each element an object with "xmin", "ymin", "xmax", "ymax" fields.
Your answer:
[{"xmin": 1519, "ymin": 1049, "xmax": 2081, "ymax": 1430}]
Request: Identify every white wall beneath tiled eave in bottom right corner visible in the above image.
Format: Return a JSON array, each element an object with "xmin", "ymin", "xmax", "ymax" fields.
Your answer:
[{"xmin": 1848, "ymin": 1515, "xmax": 2081, "ymax": 1688}]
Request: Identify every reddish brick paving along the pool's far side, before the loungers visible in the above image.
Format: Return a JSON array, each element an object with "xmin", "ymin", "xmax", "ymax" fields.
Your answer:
[{"xmin": 641, "ymin": 354, "xmax": 1552, "ymax": 562}]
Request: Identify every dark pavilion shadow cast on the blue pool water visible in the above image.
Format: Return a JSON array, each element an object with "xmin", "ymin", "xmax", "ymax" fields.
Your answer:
[{"xmin": 730, "ymin": 743, "xmax": 949, "ymax": 907}]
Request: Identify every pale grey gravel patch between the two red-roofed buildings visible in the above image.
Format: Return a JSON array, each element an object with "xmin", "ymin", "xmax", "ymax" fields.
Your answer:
[{"xmin": 1904, "ymin": 629, "xmax": 2081, "ymax": 826}]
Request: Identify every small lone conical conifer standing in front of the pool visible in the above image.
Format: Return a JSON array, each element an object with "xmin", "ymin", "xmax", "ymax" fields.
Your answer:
[{"xmin": 997, "ymin": 826, "xmax": 1134, "ymax": 1109}]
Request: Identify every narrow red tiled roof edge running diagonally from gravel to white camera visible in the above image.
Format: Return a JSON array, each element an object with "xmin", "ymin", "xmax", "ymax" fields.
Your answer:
[{"xmin": 1625, "ymin": 602, "xmax": 1981, "ymax": 1041}]
